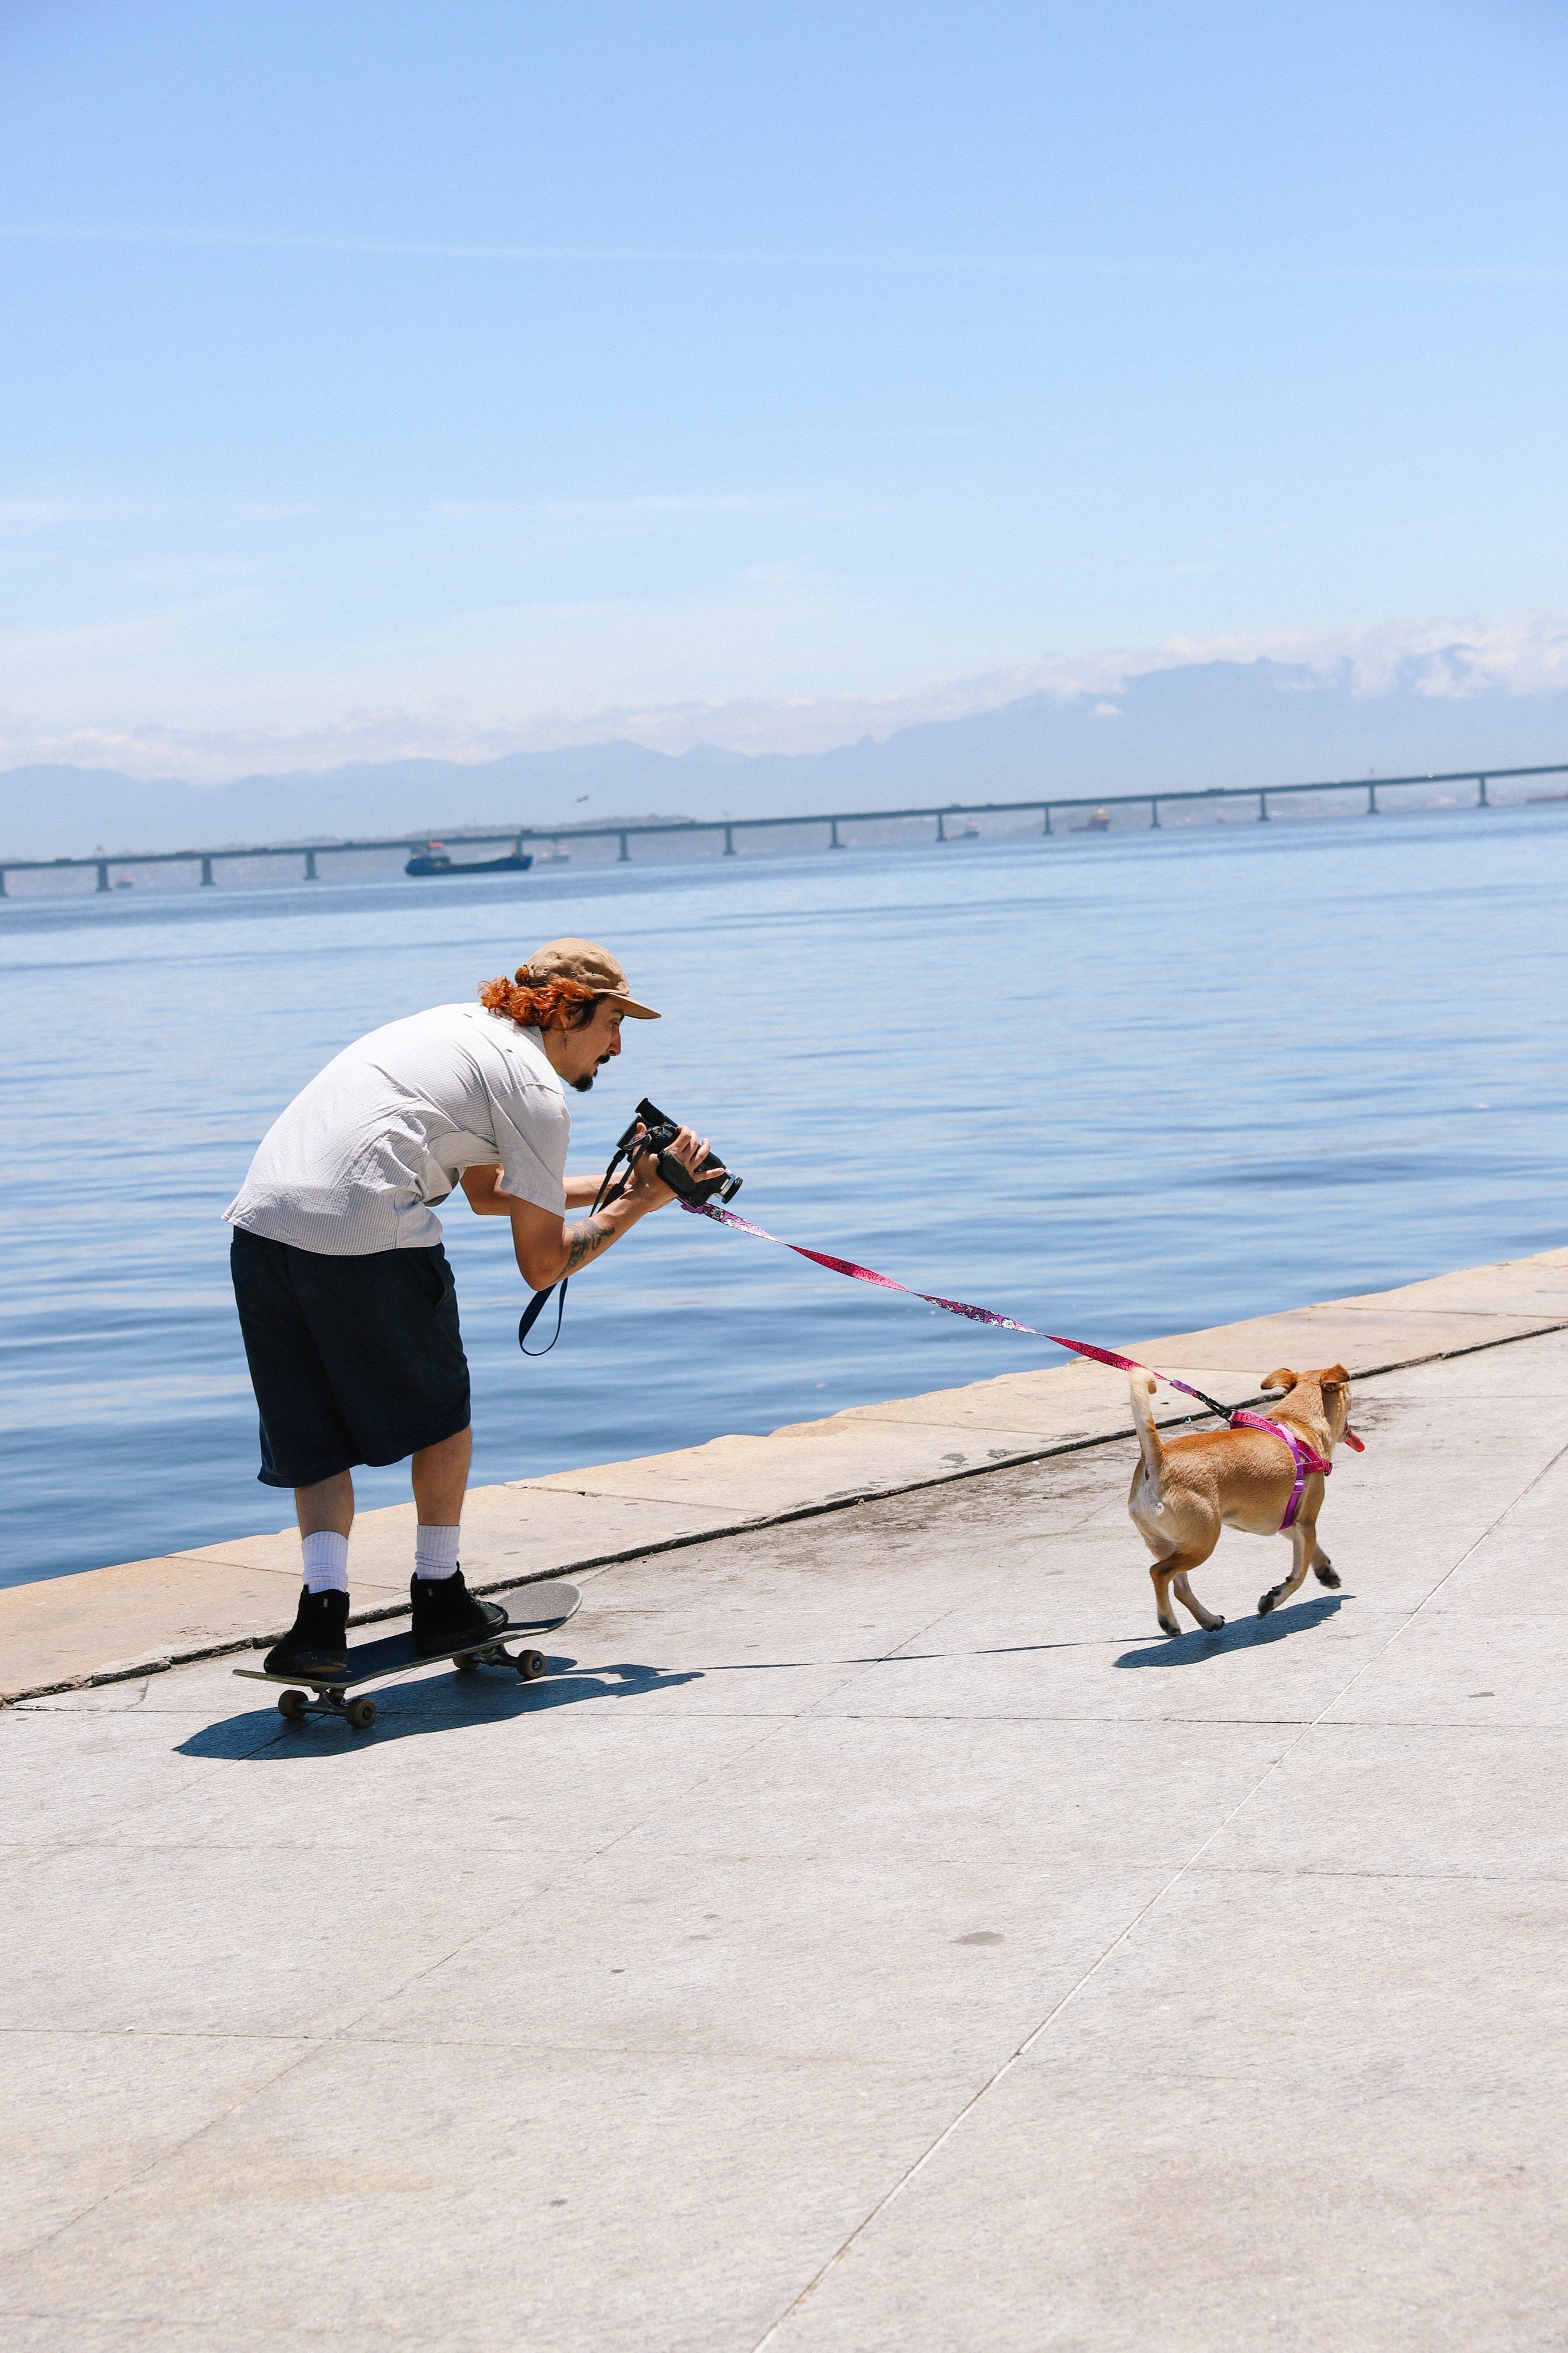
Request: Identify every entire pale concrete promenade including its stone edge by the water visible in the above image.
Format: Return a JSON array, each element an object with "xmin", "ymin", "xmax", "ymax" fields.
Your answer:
[{"xmin": 0, "ymin": 1252, "xmax": 1568, "ymax": 2353}]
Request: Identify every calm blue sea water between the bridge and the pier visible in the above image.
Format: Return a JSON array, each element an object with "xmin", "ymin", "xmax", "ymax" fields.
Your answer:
[{"xmin": 0, "ymin": 809, "xmax": 1568, "ymax": 1584}]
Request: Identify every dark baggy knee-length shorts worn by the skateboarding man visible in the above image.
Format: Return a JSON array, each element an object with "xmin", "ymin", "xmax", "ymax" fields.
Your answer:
[{"xmin": 228, "ymin": 1226, "xmax": 469, "ymax": 1487}]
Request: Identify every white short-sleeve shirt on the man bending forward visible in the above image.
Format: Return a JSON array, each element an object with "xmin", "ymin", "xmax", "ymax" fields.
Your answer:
[{"xmin": 223, "ymin": 1005, "xmax": 572, "ymax": 1259}]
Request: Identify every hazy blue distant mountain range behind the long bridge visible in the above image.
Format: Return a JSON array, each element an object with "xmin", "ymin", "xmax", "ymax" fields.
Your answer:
[{"xmin": 0, "ymin": 661, "xmax": 1568, "ymax": 859}]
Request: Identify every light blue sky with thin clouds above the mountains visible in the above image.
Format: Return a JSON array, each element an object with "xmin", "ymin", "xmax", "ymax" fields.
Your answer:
[{"xmin": 0, "ymin": 0, "xmax": 1568, "ymax": 774}]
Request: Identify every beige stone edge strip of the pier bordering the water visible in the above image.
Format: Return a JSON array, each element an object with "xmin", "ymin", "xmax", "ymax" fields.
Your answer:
[{"xmin": 0, "ymin": 1247, "xmax": 1568, "ymax": 1706}]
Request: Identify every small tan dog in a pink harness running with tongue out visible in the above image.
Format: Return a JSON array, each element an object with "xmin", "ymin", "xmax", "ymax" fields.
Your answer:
[{"xmin": 1127, "ymin": 1365, "xmax": 1361, "ymax": 1633}]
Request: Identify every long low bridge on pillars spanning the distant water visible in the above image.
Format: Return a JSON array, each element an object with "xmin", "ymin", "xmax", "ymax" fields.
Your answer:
[{"xmin": 0, "ymin": 760, "xmax": 1568, "ymax": 899}]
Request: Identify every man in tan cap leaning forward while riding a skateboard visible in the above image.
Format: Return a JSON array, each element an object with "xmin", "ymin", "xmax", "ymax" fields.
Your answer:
[{"xmin": 223, "ymin": 939, "xmax": 706, "ymax": 1680}]
